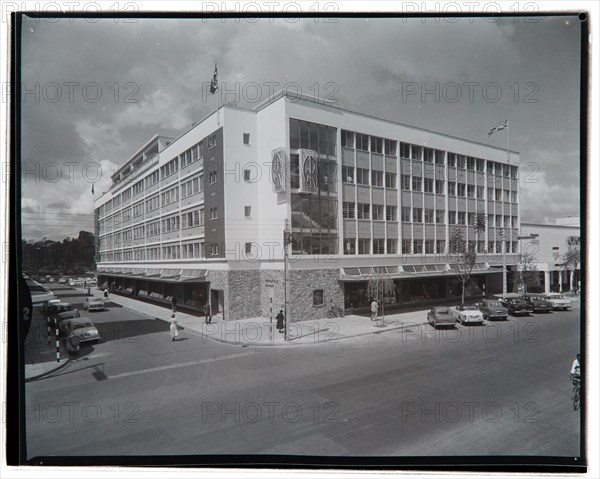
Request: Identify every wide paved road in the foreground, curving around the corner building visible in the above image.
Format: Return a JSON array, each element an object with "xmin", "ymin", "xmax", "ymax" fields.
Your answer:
[{"xmin": 27, "ymin": 286, "xmax": 580, "ymax": 458}]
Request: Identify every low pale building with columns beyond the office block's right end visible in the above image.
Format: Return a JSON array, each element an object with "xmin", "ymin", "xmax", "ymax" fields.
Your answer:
[{"xmin": 520, "ymin": 218, "xmax": 581, "ymax": 293}]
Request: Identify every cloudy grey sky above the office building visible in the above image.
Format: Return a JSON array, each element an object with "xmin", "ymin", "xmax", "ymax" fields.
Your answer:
[{"xmin": 21, "ymin": 12, "xmax": 581, "ymax": 240}]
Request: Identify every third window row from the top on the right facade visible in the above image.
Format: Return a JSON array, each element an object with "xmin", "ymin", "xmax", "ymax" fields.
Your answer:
[{"xmin": 342, "ymin": 201, "xmax": 519, "ymax": 228}]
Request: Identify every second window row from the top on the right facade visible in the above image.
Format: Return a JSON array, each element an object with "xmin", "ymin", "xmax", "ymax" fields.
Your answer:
[{"xmin": 342, "ymin": 166, "xmax": 518, "ymax": 203}]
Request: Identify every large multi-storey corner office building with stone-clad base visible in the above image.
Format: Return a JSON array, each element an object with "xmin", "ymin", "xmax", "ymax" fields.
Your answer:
[{"xmin": 95, "ymin": 92, "xmax": 519, "ymax": 321}]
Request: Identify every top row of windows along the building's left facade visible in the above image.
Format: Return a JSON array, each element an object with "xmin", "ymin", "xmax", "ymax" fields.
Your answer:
[{"xmin": 98, "ymin": 134, "xmax": 217, "ymax": 216}]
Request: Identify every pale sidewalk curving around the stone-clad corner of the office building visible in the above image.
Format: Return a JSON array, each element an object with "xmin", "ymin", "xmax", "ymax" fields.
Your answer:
[{"xmin": 85, "ymin": 289, "xmax": 428, "ymax": 346}]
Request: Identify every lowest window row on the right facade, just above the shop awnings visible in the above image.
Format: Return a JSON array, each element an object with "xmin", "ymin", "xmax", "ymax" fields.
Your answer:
[{"xmin": 344, "ymin": 238, "xmax": 518, "ymax": 255}]
